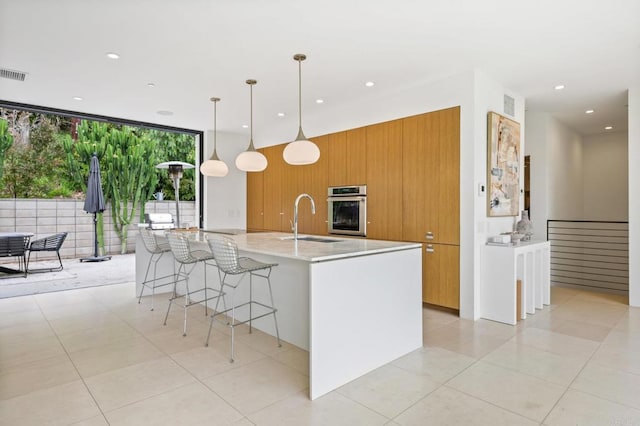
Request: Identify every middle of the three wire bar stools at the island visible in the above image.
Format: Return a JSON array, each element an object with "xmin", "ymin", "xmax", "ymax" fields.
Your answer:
[{"xmin": 164, "ymin": 232, "xmax": 226, "ymax": 336}]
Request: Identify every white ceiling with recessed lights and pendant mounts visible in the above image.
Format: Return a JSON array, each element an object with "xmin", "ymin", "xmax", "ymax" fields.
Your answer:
[{"xmin": 0, "ymin": 0, "xmax": 640, "ymax": 146}]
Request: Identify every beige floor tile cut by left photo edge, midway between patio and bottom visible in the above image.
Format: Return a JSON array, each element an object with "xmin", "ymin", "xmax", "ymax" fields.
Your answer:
[{"xmin": 0, "ymin": 336, "xmax": 65, "ymax": 371}]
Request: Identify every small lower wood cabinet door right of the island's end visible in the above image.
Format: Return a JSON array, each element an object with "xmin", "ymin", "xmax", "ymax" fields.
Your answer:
[{"xmin": 422, "ymin": 243, "xmax": 460, "ymax": 309}]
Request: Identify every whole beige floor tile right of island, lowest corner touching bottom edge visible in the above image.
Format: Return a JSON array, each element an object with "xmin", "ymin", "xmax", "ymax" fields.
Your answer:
[{"xmin": 447, "ymin": 361, "xmax": 566, "ymax": 422}]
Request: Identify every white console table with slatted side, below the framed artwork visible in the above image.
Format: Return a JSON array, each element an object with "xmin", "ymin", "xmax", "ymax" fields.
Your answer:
[{"xmin": 480, "ymin": 241, "xmax": 551, "ymax": 325}]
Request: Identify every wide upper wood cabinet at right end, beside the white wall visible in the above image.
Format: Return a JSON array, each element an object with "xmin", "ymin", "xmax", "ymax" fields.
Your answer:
[{"xmin": 402, "ymin": 107, "xmax": 460, "ymax": 244}]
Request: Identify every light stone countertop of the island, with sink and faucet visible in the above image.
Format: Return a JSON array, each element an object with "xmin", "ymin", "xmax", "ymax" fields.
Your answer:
[{"xmin": 171, "ymin": 231, "xmax": 421, "ymax": 262}]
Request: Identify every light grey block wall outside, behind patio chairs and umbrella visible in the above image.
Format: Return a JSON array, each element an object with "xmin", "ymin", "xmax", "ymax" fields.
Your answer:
[{"xmin": 0, "ymin": 198, "xmax": 197, "ymax": 263}]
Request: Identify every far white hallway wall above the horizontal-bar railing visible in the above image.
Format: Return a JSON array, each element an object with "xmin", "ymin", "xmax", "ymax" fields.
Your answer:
[{"xmin": 582, "ymin": 132, "xmax": 629, "ymax": 221}]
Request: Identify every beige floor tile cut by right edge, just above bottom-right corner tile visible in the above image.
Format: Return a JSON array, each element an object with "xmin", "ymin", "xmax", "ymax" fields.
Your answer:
[{"xmin": 571, "ymin": 362, "xmax": 640, "ymax": 409}]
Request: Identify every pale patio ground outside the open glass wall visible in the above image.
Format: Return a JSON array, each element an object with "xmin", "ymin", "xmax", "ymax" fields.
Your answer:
[{"xmin": 0, "ymin": 253, "xmax": 136, "ymax": 299}]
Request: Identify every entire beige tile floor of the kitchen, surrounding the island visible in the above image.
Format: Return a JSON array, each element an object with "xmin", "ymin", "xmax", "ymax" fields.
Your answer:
[{"xmin": 0, "ymin": 284, "xmax": 640, "ymax": 426}]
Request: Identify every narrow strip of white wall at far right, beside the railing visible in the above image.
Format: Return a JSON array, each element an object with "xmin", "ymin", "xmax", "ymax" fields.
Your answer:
[{"xmin": 628, "ymin": 86, "xmax": 640, "ymax": 306}]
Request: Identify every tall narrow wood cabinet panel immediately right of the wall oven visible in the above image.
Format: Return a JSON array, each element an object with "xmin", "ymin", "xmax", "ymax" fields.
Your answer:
[{"xmin": 366, "ymin": 120, "xmax": 402, "ymax": 240}]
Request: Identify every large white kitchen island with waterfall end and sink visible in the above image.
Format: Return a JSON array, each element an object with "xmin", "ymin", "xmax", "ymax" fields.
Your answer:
[{"xmin": 136, "ymin": 231, "xmax": 422, "ymax": 399}]
